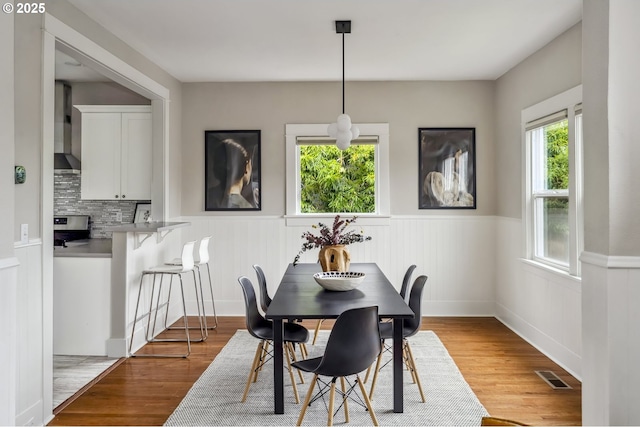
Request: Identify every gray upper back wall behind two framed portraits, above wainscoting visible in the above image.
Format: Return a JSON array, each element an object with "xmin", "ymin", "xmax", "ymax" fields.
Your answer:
[{"xmin": 182, "ymin": 81, "xmax": 496, "ymax": 215}]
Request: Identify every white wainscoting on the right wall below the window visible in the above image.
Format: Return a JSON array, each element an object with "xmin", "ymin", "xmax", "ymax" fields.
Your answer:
[{"xmin": 495, "ymin": 218, "xmax": 582, "ymax": 379}]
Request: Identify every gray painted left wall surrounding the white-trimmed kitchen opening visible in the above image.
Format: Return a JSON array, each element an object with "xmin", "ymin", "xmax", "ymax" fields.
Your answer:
[{"xmin": 11, "ymin": 0, "xmax": 182, "ymax": 241}]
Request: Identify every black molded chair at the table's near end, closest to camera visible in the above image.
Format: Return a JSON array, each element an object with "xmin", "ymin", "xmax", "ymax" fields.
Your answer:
[{"xmin": 293, "ymin": 306, "xmax": 382, "ymax": 426}]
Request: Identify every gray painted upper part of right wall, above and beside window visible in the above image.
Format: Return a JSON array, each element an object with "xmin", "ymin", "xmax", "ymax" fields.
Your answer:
[{"xmin": 493, "ymin": 23, "xmax": 582, "ymax": 218}]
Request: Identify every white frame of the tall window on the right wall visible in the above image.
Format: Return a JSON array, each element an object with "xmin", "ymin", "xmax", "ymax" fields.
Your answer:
[{"xmin": 521, "ymin": 85, "xmax": 584, "ymax": 277}]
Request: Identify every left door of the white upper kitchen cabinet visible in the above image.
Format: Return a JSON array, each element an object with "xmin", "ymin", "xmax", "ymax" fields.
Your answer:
[{"xmin": 81, "ymin": 113, "xmax": 122, "ymax": 200}]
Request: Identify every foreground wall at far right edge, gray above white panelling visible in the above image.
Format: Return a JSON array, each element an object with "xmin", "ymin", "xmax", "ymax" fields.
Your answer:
[{"xmin": 581, "ymin": 0, "xmax": 640, "ymax": 425}]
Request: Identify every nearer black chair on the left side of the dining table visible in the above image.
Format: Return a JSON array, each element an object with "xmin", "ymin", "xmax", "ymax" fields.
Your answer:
[{"xmin": 238, "ymin": 276, "xmax": 309, "ymax": 403}]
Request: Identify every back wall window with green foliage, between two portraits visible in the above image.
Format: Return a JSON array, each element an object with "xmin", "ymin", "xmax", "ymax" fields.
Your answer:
[{"xmin": 286, "ymin": 124, "xmax": 389, "ymax": 224}]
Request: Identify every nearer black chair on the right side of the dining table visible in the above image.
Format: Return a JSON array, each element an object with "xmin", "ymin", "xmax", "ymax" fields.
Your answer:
[{"xmin": 369, "ymin": 276, "xmax": 427, "ymax": 402}]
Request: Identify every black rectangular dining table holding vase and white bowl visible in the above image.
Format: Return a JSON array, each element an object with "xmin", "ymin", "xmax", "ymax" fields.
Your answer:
[{"xmin": 265, "ymin": 263, "xmax": 414, "ymax": 414}]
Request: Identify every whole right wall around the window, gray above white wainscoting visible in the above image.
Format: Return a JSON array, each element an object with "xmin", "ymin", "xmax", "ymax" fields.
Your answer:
[{"xmin": 495, "ymin": 24, "xmax": 582, "ymax": 378}]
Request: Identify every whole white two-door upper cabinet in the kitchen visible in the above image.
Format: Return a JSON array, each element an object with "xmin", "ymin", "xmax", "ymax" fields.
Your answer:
[{"xmin": 75, "ymin": 105, "xmax": 152, "ymax": 200}]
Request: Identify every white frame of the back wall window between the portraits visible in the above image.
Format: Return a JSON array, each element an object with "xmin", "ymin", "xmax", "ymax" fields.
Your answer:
[{"xmin": 285, "ymin": 123, "xmax": 390, "ymax": 226}]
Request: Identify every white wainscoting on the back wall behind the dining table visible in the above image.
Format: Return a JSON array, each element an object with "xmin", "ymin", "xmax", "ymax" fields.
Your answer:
[{"xmin": 180, "ymin": 216, "xmax": 495, "ymax": 316}]
